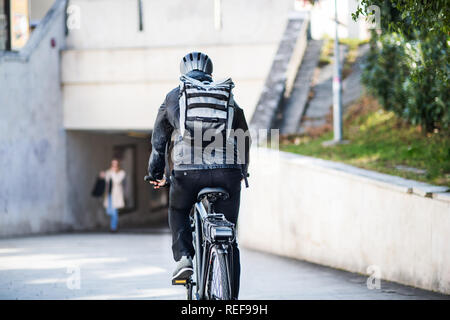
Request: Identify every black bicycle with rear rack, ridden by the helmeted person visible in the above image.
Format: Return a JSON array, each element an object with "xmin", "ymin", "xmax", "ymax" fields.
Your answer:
[{"xmin": 144, "ymin": 176, "xmax": 236, "ymax": 300}]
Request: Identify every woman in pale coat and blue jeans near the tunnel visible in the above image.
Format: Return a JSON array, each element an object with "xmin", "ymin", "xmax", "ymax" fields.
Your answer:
[{"xmin": 100, "ymin": 159, "xmax": 126, "ymax": 232}]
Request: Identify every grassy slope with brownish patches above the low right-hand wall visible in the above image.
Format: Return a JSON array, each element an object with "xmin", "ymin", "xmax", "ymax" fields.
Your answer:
[{"xmin": 280, "ymin": 96, "xmax": 450, "ymax": 187}]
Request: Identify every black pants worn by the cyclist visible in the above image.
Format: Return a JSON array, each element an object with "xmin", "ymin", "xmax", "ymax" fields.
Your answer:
[{"xmin": 169, "ymin": 169, "xmax": 242, "ymax": 298}]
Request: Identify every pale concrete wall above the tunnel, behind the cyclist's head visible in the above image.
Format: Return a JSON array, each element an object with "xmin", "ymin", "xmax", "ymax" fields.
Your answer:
[{"xmin": 62, "ymin": 44, "xmax": 274, "ymax": 131}]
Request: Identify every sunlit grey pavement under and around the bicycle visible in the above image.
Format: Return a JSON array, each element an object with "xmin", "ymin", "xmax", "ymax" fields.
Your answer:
[{"xmin": 0, "ymin": 229, "xmax": 450, "ymax": 299}]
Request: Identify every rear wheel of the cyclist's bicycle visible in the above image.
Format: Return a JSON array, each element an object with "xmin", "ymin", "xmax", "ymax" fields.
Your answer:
[{"xmin": 206, "ymin": 247, "xmax": 231, "ymax": 300}]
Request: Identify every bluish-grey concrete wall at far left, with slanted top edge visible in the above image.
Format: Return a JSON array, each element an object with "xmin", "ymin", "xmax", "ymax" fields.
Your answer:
[{"xmin": 0, "ymin": 2, "xmax": 69, "ymax": 236}]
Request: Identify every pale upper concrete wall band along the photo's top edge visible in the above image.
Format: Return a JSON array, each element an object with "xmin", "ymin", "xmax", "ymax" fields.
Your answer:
[{"xmin": 67, "ymin": 0, "xmax": 294, "ymax": 49}]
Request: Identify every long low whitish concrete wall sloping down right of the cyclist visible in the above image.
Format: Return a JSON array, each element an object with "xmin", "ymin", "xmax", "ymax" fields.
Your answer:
[{"xmin": 239, "ymin": 149, "xmax": 450, "ymax": 294}]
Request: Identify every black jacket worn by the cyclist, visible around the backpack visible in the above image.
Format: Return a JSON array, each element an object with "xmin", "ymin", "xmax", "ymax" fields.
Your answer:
[{"xmin": 148, "ymin": 71, "xmax": 251, "ymax": 179}]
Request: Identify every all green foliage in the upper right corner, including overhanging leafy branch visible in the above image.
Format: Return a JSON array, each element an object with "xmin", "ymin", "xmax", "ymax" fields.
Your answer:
[{"xmin": 353, "ymin": 0, "xmax": 450, "ymax": 132}]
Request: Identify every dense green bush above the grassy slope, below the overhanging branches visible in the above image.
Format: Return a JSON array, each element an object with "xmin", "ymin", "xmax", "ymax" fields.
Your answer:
[{"xmin": 362, "ymin": 32, "xmax": 450, "ymax": 132}]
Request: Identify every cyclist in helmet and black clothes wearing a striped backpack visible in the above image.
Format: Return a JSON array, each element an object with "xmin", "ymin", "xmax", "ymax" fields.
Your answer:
[{"xmin": 148, "ymin": 52, "xmax": 251, "ymax": 299}]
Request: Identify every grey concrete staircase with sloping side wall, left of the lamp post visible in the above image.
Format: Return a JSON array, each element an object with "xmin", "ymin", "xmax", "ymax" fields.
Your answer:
[{"xmin": 250, "ymin": 11, "xmax": 367, "ymax": 134}]
